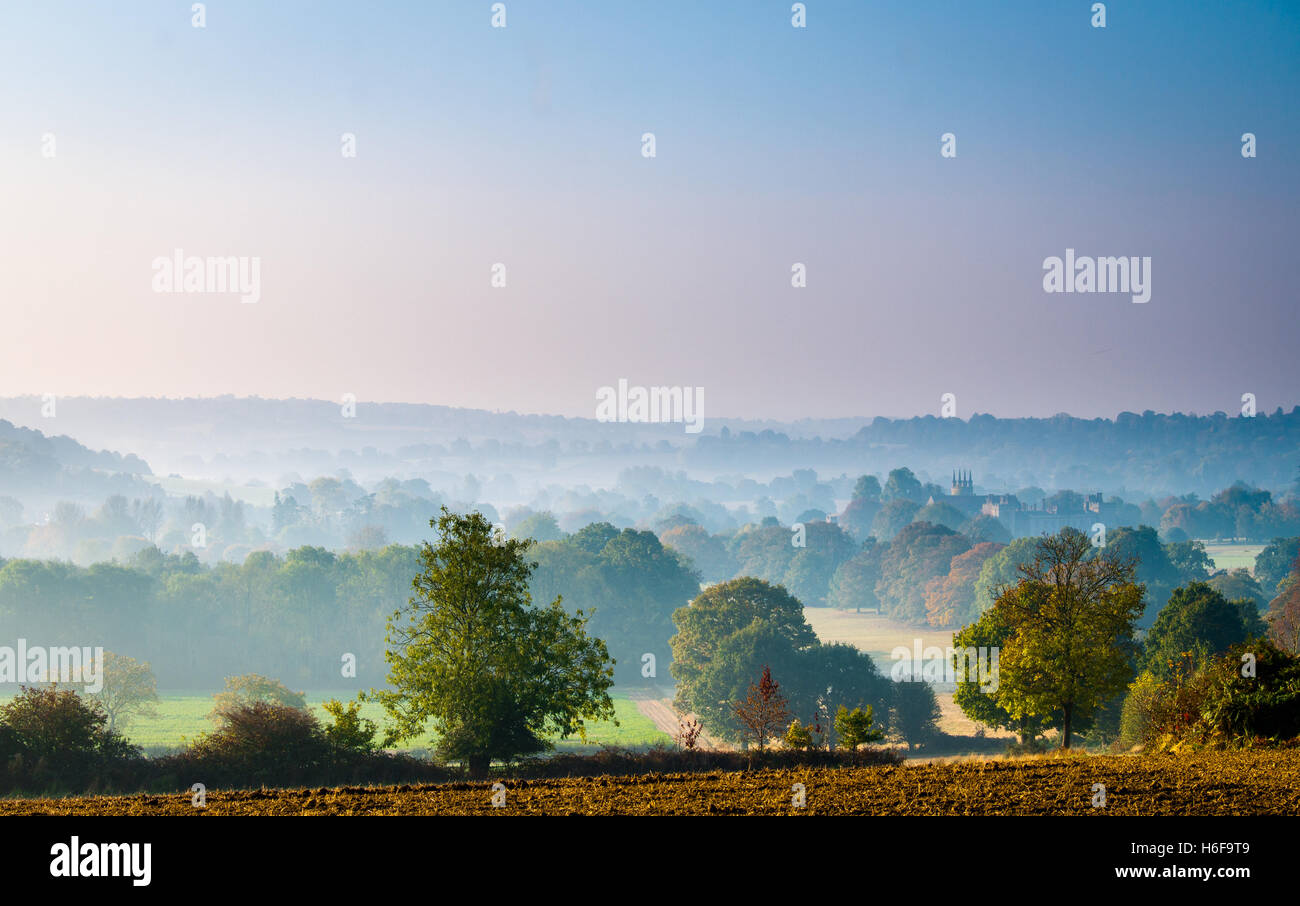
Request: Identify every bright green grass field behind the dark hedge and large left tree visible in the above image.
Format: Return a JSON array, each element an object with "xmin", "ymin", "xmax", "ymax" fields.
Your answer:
[{"xmin": 0, "ymin": 690, "xmax": 671, "ymax": 751}]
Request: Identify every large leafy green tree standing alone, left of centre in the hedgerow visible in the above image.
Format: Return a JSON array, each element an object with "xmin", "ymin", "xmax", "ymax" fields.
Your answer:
[{"xmin": 372, "ymin": 507, "xmax": 614, "ymax": 777}]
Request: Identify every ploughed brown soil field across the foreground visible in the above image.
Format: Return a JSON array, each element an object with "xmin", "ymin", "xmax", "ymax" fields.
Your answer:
[{"xmin": 0, "ymin": 750, "xmax": 1300, "ymax": 816}]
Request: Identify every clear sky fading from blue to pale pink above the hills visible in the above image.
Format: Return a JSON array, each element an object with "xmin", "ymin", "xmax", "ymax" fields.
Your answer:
[{"xmin": 0, "ymin": 0, "xmax": 1300, "ymax": 420}]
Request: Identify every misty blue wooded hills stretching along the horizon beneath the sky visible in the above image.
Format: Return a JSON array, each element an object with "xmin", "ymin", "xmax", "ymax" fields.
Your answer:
[{"xmin": 0, "ymin": 396, "xmax": 1300, "ymax": 497}]
